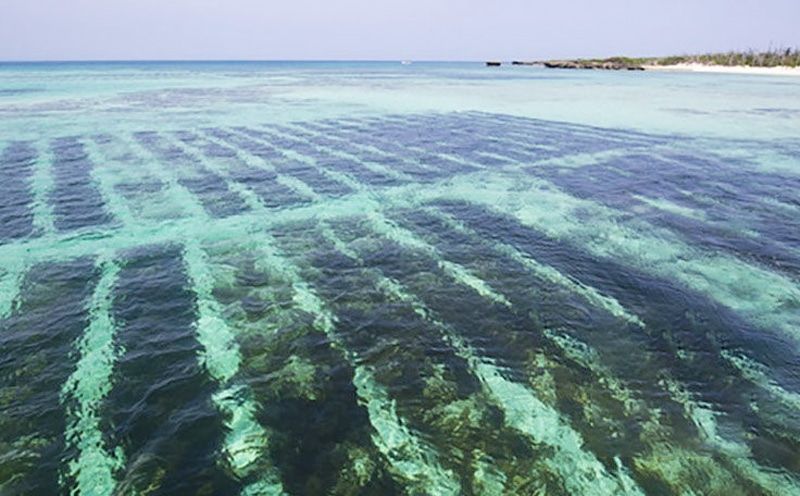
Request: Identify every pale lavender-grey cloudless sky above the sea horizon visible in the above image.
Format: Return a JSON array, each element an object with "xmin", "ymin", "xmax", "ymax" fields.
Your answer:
[{"xmin": 0, "ymin": 0, "xmax": 800, "ymax": 61}]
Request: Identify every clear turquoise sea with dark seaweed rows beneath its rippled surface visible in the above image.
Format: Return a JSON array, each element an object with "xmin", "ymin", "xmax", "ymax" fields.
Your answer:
[{"xmin": 0, "ymin": 62, "xmax": 800, "ymax": 495}]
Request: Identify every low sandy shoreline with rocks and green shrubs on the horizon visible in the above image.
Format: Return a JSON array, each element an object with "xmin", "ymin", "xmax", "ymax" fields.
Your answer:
[{"xmin": 494, "ymin": 48, "xmax": 800, "ymax": 74}]
